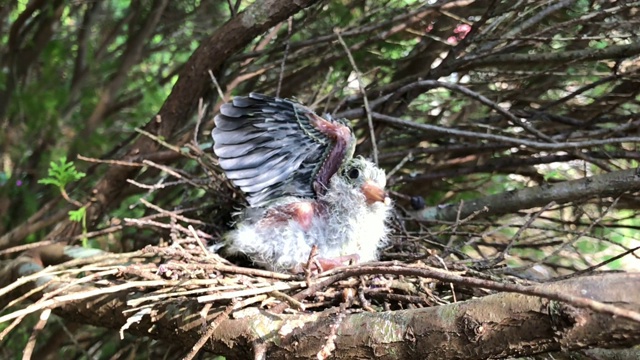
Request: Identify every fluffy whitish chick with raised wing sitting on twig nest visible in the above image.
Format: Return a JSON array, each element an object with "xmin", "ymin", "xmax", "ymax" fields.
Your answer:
[{"xmin": 212, "ymin": 93, "xmax": 391, "ymax": 271}]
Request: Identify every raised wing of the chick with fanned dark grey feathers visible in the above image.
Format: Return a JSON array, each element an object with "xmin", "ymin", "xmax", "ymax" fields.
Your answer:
[{"xmin": 212, "ymin": 93, "xmax": 355, "ymax": 207}]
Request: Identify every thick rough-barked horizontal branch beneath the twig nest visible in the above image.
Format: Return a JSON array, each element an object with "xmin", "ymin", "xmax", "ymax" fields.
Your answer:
[{"xmin": 0, "ymin": 249, "xmax": 640, "ymax": 359}]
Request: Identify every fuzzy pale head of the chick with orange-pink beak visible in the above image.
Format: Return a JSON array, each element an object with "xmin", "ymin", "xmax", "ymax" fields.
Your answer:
[{"xmin": 332, "ymin": 156, "xmax": 391, "ymax": 206}]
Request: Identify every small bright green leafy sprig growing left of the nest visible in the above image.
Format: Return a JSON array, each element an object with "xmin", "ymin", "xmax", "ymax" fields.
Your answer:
[{"xmin": 38, "ymin": 156, "xmax": 88, "ymax": 247}]
